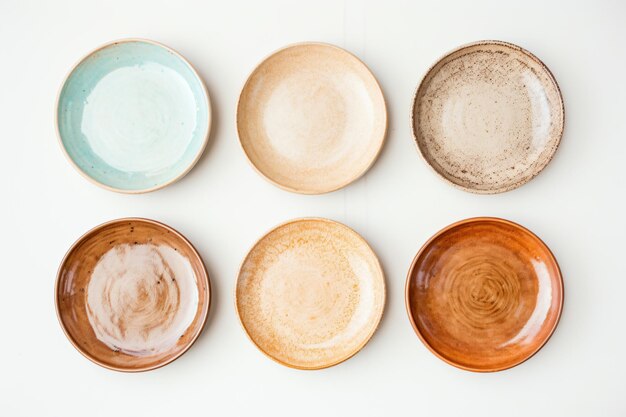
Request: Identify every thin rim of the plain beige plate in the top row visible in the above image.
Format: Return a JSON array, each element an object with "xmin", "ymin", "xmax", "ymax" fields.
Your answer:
[{"xmin": 235, "ymin": 41, "xmax": 389, "ymax": 195}]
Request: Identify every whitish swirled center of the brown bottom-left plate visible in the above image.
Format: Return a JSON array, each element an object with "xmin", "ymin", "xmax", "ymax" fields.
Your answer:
[{"xmin": 87, "ymin": 244, "xmax": 198, "ymax": 356}]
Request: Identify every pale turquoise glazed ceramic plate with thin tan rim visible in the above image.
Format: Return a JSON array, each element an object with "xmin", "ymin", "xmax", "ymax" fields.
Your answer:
[{"xmin": 56, "ymin": 39, "xmax": 211, "ymax": 193}]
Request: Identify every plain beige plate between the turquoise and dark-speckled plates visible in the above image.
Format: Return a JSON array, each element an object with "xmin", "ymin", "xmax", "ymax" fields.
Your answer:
[{"xmin": 237, "ymin": 43, "xmax": 387, "ymax": 194}]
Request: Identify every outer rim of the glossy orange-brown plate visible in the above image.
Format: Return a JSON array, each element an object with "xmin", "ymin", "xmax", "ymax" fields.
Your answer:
[{"xmin": 404, "ymin": 216, "xmax": 565, "ymax": 373}]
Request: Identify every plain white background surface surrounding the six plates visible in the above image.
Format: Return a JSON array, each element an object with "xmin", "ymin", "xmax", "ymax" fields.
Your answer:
[{"xmin": 0, "ymin": 0, "xmax": 626, "ymax": 417}]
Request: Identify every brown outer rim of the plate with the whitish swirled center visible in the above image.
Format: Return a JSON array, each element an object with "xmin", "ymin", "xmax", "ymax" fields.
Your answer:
[{"xmin": 54, "ymin": 217, "xmax": 213, "ymax": 373}]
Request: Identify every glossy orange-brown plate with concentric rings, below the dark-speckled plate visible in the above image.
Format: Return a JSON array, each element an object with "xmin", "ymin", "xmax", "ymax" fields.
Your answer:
[{"xmin": 406, "ymin": 217, "xmax": 563, "ymax": 372}]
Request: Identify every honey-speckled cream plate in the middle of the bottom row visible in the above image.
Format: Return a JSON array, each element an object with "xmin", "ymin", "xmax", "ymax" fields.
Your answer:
[{"xmin": 235, "ymin": 219, "xmax": 385, "ymax": 369}]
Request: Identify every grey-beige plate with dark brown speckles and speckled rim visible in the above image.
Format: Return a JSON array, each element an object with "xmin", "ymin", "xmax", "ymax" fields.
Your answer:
[{"xmin": 411, "ymin": 41, "xmax": 564, "ymax": 194}]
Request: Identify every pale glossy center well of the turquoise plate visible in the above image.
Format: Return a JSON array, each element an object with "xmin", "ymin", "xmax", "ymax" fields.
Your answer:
[{"xmin": 81, "ymin": 62, "xmax": 196, "ymax": 172}]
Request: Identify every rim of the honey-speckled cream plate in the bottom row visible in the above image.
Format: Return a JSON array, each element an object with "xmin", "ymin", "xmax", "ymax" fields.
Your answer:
[{"xmin": 233, "ymin": 217, "xmax": 387, "ymax": 371}]
